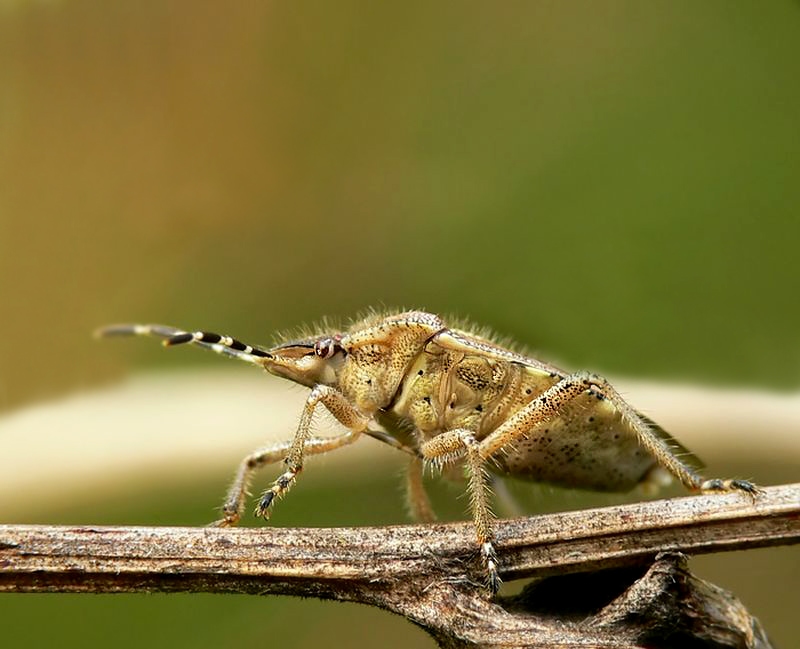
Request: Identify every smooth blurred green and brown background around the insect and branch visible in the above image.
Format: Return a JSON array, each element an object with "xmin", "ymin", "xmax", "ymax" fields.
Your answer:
[{"xmin": 0, "ymin": 0, "xmax": 800, "ymax": 647}]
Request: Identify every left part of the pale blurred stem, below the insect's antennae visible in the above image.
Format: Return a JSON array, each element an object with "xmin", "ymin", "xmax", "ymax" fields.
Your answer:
[{"xmin": 0, "ymin": 370, "xmax": 388, "ymax": 520}]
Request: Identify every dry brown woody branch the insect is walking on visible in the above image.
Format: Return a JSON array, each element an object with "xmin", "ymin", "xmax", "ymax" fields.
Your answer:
[{"xmin": 0, "ymin": 484, "xmax": 800, "ymax": 647}]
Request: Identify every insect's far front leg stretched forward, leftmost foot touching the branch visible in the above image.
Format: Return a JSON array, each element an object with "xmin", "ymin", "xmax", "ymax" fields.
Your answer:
[{"xmin": 212, "ymin": 431, "xmax": 357, "ymax": 527}]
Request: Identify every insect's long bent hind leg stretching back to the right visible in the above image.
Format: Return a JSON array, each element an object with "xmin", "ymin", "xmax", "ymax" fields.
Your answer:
[{"xmin": 480, "ymin": 372, "xmax": 758, "ymax": 495}]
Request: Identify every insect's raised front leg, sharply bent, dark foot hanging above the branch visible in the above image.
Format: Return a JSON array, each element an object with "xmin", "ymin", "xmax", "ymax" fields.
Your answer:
[{"xmin": 255, "ymin": 385, "xmax": 369, "ymax": 518}]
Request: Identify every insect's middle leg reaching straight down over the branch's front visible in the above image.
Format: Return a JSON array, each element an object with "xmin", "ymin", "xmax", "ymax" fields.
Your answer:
[{"xmin": 421, "ymin": 429, "xmax": 500, "ymax": 593}]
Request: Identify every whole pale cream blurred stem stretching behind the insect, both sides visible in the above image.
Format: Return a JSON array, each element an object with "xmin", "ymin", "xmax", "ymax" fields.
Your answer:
[{"xmin": 0, "ymin": 370, "xmax": 800, "ymax": 521}]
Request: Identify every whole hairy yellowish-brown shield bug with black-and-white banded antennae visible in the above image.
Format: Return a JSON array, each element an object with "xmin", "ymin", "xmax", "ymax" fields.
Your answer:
[{"xmin": 98, "ymin": 311, "xmax": 758, "ymax": 592}]
